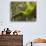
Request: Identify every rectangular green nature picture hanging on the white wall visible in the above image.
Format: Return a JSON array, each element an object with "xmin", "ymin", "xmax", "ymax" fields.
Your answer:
[{"xmin": 10, "ymin": 2, "xmax": 36, "ymax": 21}]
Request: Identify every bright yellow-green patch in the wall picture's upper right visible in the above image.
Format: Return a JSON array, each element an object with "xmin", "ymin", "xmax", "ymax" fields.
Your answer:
[{"xmin": 23, "ymin": 2, "xmax": 36, "ymax": 16}]
